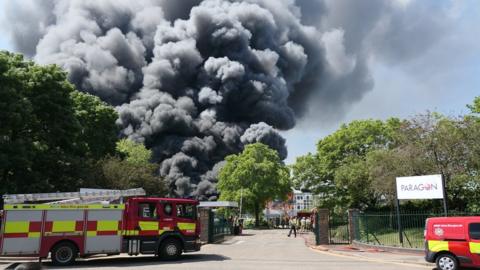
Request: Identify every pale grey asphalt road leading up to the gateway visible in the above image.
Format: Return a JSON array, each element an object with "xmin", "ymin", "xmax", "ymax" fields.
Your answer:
[{"xmin": 11, "ymin": 230, "xmax": 432, "ymax": 270}]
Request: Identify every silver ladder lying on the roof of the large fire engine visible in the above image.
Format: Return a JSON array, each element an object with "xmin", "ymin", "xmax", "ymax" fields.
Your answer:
[{"xmin": 3, "ymin": 188, "xmax": 146, "ymax": 204}]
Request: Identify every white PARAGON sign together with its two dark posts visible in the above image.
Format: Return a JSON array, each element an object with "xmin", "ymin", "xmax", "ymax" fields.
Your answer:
[{"xmin": 395, "ymin": 174, "xmax": 448, "ymax": 246}]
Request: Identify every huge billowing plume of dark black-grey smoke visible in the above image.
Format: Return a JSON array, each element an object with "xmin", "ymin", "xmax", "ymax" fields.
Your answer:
[{"xmin": 3, "ymin": 0, "xmax": 454, "ymax": 199}]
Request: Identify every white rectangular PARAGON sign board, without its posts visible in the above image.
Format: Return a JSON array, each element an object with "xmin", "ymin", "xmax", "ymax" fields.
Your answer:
[{"xmin": 397, "ymin": 174, "xmax": 444, "ymax": 200}]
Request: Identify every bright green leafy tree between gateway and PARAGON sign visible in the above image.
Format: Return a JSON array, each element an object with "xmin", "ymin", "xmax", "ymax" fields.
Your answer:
[{"xmin": 292, "ymin": 118, "xmax": 402, "ymax": 211}]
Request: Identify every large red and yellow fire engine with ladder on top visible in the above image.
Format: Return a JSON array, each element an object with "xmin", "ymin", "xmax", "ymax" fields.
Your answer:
[{"xmin": 0, "ymin": 189, "xmax": 200, "ymax": 265}]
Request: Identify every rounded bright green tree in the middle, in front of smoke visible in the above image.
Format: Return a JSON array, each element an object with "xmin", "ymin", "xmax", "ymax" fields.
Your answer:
[{"xmin": 217, "ymin": 143, "xmax": 291, "ymax": 226}]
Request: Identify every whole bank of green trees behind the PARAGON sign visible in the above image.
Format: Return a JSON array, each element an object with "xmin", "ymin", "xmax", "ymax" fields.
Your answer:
[{"xmin": 291, "ymin": 98, "xmax": 480, "ymax": 211}]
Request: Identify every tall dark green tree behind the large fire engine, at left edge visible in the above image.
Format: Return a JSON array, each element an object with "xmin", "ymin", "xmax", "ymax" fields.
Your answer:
[{"xmin": 0, "ymin": 52, "xmax": 116, "ymax": 193}]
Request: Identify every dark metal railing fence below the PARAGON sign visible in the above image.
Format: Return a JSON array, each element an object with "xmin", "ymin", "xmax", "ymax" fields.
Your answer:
[{"xmin": 351, "ymin": 211, "xmax": 477, "ymax": 248}]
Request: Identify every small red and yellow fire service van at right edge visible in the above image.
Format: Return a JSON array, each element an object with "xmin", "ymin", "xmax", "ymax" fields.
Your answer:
[{"xmin": 424, "ymin": 217, "xmax": 480, "ymax": 270}]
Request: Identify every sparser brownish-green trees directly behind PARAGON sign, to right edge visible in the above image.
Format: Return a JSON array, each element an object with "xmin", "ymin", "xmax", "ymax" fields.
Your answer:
[{"xmin": 367, "ymin": 113, "xmax": 480, "ymax": 211}]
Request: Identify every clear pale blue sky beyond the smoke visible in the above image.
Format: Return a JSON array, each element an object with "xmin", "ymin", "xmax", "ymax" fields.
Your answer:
[{"xmin": 0, "ymin": 0, "xmax": 480, "ymax": 164}]
